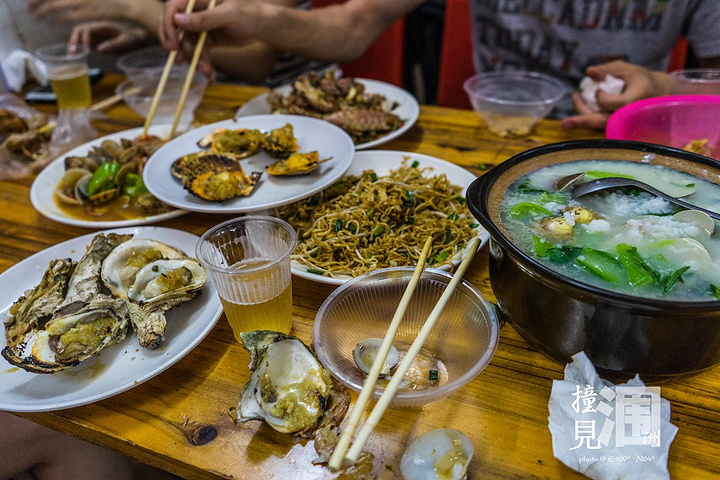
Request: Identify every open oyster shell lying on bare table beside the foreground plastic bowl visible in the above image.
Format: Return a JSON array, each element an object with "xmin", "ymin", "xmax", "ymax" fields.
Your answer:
[{"xmin": 237, "ymin": 330, "xmax": 332, "ymax": 433}]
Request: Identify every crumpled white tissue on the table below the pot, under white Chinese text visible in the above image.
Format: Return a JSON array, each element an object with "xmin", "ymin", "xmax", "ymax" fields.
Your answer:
[{"xmin": 548, "ymin": 352, "xmax": 678, "ymax": 480}]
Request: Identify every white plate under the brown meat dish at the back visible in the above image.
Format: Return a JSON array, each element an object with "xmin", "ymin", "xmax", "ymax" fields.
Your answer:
[{"xmin": 235, "ymin": 78, "xmax": 420, "ymax": 150}]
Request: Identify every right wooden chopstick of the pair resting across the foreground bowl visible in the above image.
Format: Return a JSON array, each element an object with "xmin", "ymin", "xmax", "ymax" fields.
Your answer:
[{"xmin": 345, "ymin": 238, "xmax": 480, "ymax": 463}]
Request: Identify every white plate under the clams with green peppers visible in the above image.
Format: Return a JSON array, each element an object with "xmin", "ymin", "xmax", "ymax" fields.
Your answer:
[{"xmin": 30, "ymin": 125, "xmax": 187, "ymax": 228}]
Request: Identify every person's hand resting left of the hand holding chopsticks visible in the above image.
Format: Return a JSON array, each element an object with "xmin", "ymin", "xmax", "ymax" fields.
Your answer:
[{"xmin": 69, "ymin": 21, "xmax": 150, "ymax": 53}]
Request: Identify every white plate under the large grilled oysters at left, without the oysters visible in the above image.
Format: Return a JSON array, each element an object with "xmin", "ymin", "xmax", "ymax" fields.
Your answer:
[{"xmin": 0, "ymin": 227, "xmax": 222, "ymax": 412}]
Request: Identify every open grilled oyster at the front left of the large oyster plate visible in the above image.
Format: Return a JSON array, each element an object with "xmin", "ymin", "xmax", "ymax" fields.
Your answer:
[{"xmin": 2, "ymin": 295, "xmax": 129, "ymax": 373}]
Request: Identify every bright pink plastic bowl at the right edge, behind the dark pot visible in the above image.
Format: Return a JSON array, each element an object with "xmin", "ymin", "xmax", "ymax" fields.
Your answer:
[{"xmin": 605, "ymin": 95, "xmax": 720, "ymax": 159}]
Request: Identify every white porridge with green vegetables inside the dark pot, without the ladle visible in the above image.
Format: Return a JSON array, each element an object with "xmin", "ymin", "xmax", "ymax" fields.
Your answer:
[{"xmin": 501, "ymin": 160, "xmax": 720, "ymax": 301}]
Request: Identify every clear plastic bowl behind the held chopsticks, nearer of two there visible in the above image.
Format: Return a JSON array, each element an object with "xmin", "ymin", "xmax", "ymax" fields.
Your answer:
[{"xmin": 115, "ymin": 72, "xmax": 207, "ymax": 127}]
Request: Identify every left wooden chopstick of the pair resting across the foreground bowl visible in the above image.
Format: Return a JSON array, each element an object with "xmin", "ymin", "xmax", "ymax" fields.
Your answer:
[{"xmin": 328, "ymin": 237, "xmax": 432, "ymax": 470}]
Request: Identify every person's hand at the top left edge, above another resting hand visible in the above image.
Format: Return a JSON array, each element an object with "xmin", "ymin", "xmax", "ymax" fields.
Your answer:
[{"xmin": 27, "ymin": 0, "xmax": 132, "ymax": 24}]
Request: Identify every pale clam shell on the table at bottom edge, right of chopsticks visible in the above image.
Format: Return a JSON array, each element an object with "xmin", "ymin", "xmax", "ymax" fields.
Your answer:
[{"xmin": 400, "ymin": 428, "xmax": 474, "ymax": 480}]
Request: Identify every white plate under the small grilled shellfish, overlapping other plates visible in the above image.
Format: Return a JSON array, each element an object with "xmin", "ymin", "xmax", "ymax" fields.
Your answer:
[{"xmin": 143, "ymin": 115, "xmax": 355, "ymax": 213}]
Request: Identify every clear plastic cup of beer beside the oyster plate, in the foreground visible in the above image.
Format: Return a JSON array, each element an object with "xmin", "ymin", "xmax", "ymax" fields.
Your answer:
[{"xmin": 195, "ymin": 216, "xmax": 297, "ymax": 341}]
